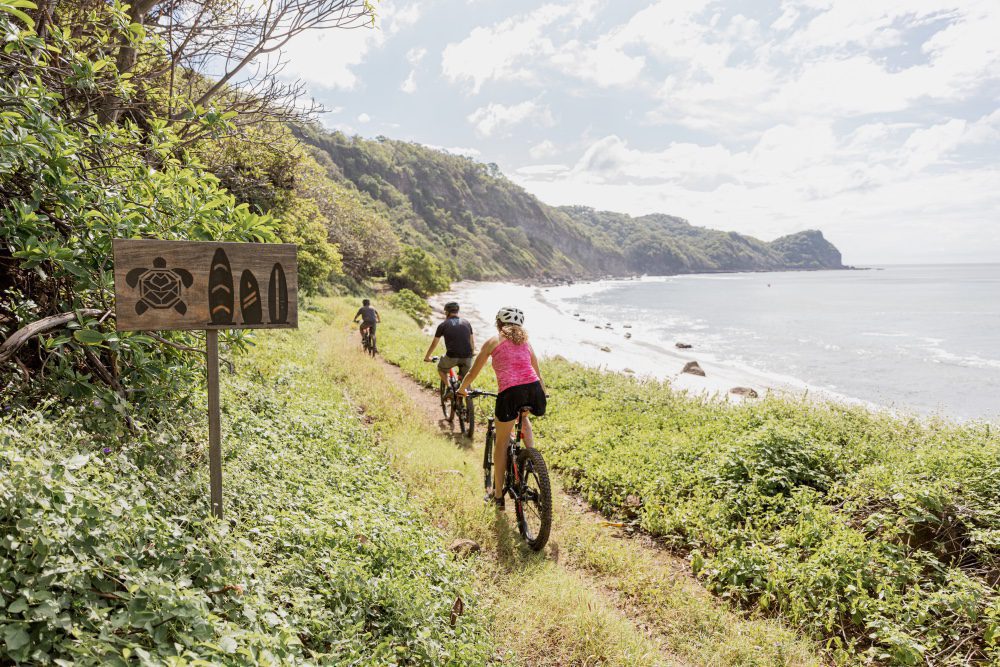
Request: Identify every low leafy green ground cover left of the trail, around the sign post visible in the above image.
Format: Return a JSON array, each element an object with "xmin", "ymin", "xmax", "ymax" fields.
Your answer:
[{"xmin": 0, "ymin": 314, "xmax": 492, "ymax": 665}]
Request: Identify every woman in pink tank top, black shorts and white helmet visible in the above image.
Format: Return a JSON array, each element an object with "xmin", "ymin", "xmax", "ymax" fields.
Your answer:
[{"xmin": 458, "ymin": 308, "xmax": 545, "ymax": 509}]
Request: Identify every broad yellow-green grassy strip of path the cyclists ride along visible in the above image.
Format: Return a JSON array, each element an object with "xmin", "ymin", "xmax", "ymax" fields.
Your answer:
[{"xmin": 360, "ymin": 304, "xmax": 821, "ymax": 667}]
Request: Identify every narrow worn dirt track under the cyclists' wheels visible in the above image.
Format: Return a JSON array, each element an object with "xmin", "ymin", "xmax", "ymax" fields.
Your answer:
[{"xmin": 368, "ymin": 357, "xmax": 820, "ymax": 665}]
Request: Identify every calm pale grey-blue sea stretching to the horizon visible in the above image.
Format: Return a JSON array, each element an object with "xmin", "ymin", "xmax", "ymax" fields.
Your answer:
[{"xmin": 542, "ymin": 264, "xmax": 1000, "ymax": 422}]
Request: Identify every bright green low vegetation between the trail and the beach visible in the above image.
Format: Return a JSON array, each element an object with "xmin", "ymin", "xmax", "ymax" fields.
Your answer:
[{"xmin": 374, "ymin": 304, "xmax": 1000, "ymax": 665}]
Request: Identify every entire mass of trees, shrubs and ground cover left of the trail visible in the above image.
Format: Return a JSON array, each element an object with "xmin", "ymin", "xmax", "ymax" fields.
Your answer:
[{"xmin": 0, "ymin": 0, "xmax": 489, "ymax": 665}]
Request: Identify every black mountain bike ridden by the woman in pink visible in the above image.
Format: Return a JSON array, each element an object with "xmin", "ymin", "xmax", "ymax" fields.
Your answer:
[{"xmin": 469, "ymin": 389, "xmax": 552, "ymax": 551}]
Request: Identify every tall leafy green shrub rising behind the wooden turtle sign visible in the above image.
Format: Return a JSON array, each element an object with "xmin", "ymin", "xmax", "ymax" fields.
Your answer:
[{"xmin": 0, "ymin": 4, "xmax": 277, "ymax": 428}]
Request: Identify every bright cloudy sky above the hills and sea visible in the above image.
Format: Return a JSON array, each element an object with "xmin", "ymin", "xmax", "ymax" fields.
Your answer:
[{"xmin": 285, "ymin": 0, "xmax": 1000, "ymax": 264}]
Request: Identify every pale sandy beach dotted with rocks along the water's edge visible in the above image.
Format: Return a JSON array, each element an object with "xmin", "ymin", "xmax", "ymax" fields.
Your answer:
[{"xmin": 428, "ymin": 281, "xmax": 853, "ymax": 402}]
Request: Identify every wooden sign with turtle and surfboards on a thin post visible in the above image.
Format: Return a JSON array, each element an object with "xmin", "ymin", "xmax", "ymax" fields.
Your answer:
[{"xmin": 113, "ymin": 239, "xmax": 299, "ymax": 519}]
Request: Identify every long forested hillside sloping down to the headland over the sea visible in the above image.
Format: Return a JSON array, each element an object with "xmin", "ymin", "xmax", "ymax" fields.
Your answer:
[{"xmin": 296, "ymin": 127, "xmax": 843, "ymax": 279}]
